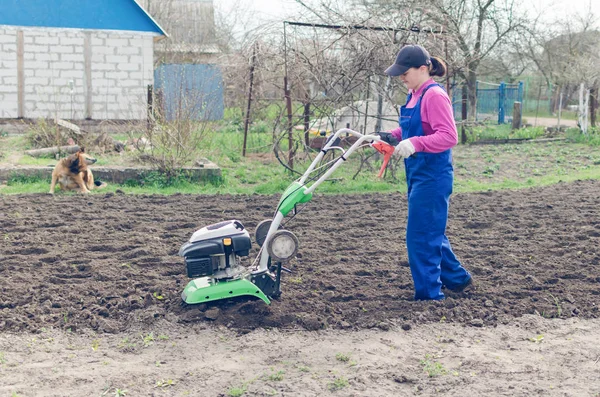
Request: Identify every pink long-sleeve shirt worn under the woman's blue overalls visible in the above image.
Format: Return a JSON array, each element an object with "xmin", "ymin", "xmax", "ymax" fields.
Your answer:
[{"xmin": 390, "ymin": 79, "xmax": 458, "ymax": 153}]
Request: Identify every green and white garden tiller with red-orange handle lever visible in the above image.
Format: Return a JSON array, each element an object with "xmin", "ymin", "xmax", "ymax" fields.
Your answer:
[{"xmin": 179, "ymin": 128, "xmax": 394, "ymax": 304}]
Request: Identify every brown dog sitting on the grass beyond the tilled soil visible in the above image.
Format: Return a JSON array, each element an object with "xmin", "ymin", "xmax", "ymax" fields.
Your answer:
[{"xmin": 50, "ymin": 147, "xmax": 106, "ymax": 194}]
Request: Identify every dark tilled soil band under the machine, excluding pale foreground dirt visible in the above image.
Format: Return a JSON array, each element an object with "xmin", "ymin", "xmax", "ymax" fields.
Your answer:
[{"xmin": 0, "ymin": 181, "xmax": 600, "ymax": 333}]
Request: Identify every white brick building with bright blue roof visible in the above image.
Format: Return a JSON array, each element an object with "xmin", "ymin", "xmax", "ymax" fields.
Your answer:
[{"xmin": 0, "ymin": 0, "xmax": 166, "ymax": 120}]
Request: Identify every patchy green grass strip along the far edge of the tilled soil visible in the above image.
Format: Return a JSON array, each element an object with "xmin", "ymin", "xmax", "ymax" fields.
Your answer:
[{"xmin": 0, "ymin": 124, "xmax": 600, "ymax": 195}]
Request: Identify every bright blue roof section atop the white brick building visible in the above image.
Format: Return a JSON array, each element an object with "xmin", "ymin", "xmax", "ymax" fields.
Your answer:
[{"xmin": 0, "ymin": 0, "xmax": 167, "ymax": 36}]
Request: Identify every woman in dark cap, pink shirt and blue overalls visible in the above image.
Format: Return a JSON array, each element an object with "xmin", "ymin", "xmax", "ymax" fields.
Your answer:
[{"xmin": 385, "ymin": 45, "xmax": 472, "ymax": 300}]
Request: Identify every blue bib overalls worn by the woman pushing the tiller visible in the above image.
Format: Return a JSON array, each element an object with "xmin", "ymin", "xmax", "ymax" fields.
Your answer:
[{"xmin": 399, "ymin": 84, "xmax": 471, "ymax": 300}]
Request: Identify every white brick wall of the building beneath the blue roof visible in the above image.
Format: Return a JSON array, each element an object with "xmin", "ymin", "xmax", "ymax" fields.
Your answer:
[{"xmin": 0, "ymin": 26, "xmax": 154, "ymax": 120}]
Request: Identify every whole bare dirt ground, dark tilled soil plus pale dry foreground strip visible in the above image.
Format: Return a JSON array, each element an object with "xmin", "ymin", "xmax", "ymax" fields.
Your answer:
[{"xmin": 0, "ymin": 181, "xmax": 600, "ymax": 396}]
